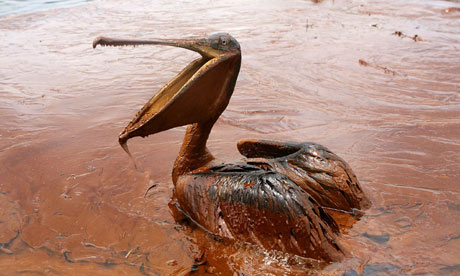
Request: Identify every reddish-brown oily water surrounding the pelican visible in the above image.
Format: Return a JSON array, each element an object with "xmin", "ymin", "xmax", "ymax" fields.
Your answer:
[{"xmin": 0, "ymin": 0, "xmax": 460, "ymax": 275}]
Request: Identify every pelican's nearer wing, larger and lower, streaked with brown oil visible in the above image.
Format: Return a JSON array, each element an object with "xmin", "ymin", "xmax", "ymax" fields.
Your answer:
[{"xmin": 176, "ymin": 165, "xmax": 344, "ymax": 260}]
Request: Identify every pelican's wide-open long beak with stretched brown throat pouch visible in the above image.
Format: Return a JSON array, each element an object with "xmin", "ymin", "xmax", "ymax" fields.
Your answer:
[{"xmin": 93, "ymin": 34, "xmax": 241, "ymax": 158}]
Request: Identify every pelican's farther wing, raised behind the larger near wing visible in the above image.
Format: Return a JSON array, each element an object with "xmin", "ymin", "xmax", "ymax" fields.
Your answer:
[{"xmin": 238, "ymin": 140, "xmax": 370, "ymax": 212}]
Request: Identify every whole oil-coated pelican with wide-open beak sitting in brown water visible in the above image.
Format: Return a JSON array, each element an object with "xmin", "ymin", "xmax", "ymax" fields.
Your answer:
[{"xmin": 93, "ymin": 33, "xmax": 369, "ymax": 261}]
